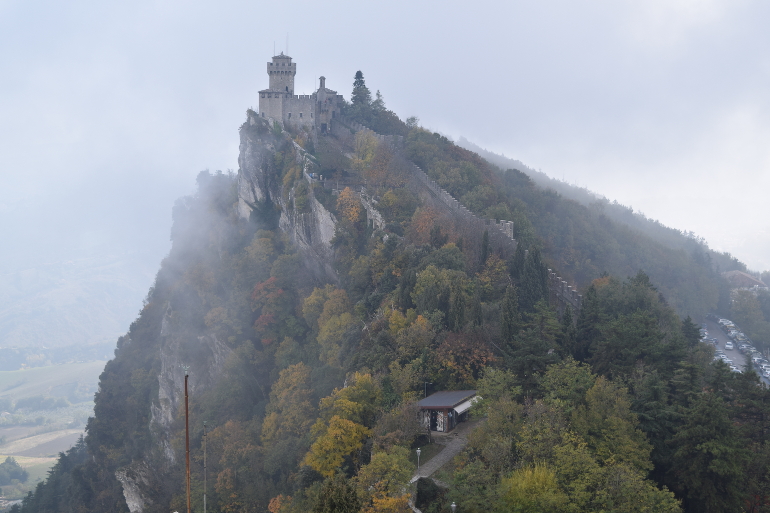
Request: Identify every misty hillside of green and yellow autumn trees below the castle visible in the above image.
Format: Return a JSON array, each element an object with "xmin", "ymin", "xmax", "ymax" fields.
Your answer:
[{"xmin": 15, "ymin": 77, "xmax": 770, "ymax": 513}]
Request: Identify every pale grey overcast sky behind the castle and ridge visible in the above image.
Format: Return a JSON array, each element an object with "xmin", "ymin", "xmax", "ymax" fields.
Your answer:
[{"xmin": 0, "ymin": 0, "xmax": 770, "ymax": 271}]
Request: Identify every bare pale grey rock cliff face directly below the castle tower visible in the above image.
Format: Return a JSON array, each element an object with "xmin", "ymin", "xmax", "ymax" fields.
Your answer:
[{"xmin": 238, "ymin": 111, "xmax": 337, "ymax": 282}]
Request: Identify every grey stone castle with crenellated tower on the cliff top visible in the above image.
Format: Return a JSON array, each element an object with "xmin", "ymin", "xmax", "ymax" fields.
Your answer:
[{"xmin": 259, "ymin": 52, "xmax": 344, "ymax": 133}]
